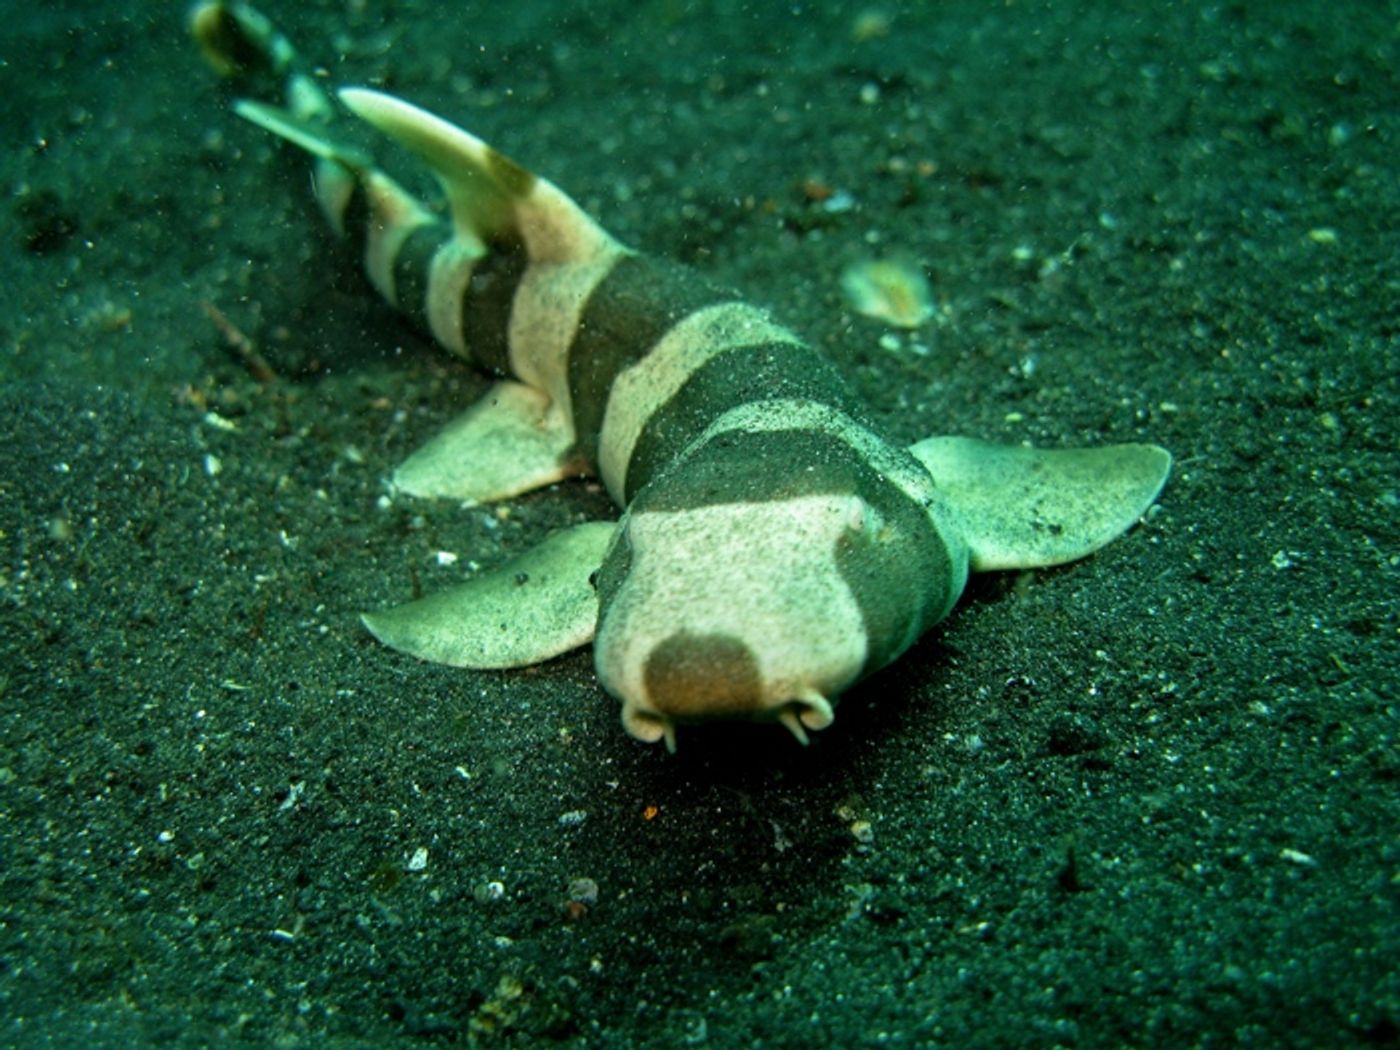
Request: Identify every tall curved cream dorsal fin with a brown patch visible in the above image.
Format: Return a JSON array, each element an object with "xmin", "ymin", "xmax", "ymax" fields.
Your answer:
[{"xmin": 339, "ymin": 88, "xmax": 617, "ymax": 263}]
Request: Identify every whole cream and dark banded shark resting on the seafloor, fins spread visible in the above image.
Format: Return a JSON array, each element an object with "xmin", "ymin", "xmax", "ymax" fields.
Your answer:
[{"xmin": 192, "ymin": 3, "xmax": 1170, "ymax": 749}]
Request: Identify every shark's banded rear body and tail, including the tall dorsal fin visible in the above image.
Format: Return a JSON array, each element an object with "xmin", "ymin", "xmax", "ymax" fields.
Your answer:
[{"xmin": 190, "ymin": 0, "xmax": 629, "ymax": 366}]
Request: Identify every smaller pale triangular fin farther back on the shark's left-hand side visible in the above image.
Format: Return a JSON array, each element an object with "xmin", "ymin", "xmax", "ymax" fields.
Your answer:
[{"xmin": 393, "ymin": 379, "xmax": 588, "ymax": 503}]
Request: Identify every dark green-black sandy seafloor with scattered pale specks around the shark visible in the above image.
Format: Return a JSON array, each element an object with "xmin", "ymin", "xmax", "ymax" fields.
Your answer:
[{"xmin": 0, "ymin": 0, "xmax": 1400, "ymax": 1047}]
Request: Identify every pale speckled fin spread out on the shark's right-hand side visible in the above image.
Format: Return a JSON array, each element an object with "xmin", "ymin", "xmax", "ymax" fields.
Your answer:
[{"xmin": 909, "ymin": 437, "xmax": 1172, "ymax": 571}]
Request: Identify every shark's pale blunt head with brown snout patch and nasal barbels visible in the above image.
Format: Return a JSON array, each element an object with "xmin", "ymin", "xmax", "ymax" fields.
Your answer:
[{"xmin": 594, "ymin": 493, "xmax": 951, "ymax": 749}]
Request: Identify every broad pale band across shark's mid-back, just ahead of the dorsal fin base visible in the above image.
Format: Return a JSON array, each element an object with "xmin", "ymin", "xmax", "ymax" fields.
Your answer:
[{"xmin": 598, "ymin": 302, "xmax": 801, "ymax": 505}]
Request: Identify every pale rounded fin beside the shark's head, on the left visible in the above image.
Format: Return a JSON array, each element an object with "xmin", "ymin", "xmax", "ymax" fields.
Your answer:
[{"xmin": 361, "ymin": 522, "xmax": 616, "ymax": 668}]
